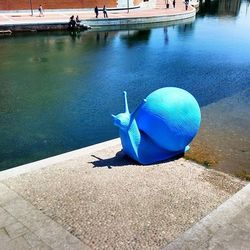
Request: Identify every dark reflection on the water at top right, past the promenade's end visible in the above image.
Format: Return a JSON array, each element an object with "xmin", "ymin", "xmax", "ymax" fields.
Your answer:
[{"xmin": 198, "ymin": 0, "xmax": 241, "ymax": 16}]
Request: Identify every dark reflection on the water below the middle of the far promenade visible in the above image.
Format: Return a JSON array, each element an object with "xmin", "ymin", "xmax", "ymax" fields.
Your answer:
[{"xmin": 120, "ymin": 30, "xmax": 151, "ymax": 47}]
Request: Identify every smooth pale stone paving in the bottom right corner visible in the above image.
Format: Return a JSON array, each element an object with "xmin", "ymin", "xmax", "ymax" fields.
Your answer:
[{"xmin": 165, "ymin": 184, "xmax": 250, "ymax": 250}]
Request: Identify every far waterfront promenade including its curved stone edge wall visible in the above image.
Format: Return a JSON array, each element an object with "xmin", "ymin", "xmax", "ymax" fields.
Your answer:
[{"xmin": 0, "ymin": 0, "xmax": 195, "ymax": 27}]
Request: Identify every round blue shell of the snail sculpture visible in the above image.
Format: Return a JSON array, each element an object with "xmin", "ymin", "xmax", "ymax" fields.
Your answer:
[{"xmin": 136, "ymin": 87, "xmax": 201, "ymax": 151}]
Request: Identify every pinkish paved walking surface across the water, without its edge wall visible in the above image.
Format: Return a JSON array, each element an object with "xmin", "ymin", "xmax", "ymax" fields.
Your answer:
[{"xmin": 0, "ymin": 0, "xmax": 193, "ymax": 25}]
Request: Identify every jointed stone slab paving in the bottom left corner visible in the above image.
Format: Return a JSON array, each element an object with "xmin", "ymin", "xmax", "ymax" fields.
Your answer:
[{"xmin": 0, "ymin": 183, "xmax": 88, "ymax": 250}]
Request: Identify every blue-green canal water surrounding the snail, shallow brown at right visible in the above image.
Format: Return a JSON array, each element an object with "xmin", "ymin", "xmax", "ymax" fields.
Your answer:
[{"xmin": 0, "ymin": 0, "xmax": 250, "ymax": 177}]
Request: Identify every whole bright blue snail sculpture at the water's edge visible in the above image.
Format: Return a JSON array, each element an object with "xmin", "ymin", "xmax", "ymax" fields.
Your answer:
[{"xmin": 112, "ymin": 87, "xmax": 201, "ymax": 164}]
